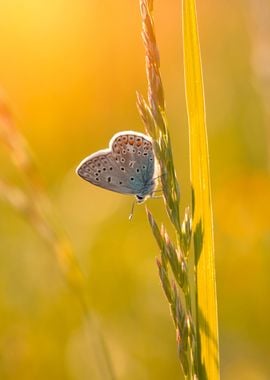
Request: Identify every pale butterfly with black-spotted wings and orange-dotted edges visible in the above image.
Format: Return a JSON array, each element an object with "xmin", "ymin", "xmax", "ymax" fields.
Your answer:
[{"xmin": 77, "ymin": 131, "xmax": 156, "ymax": 203}]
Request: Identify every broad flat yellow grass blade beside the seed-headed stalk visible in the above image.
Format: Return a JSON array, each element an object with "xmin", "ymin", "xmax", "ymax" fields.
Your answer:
[{"xmin": 182, "ymin": 0, "xmax": 219, "ymax": 380}]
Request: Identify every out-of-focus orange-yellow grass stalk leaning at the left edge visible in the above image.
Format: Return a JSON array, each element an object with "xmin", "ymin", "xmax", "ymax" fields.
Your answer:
[{"xmin": 0, "ymin": 95, "xmax": 115, "ymax": 380}]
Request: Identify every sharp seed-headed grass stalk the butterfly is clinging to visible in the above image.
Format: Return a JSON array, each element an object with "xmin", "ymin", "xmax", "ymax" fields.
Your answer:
[{"xmin": 137, "ymin": 0, "xmax": 198, "ymax": 379}]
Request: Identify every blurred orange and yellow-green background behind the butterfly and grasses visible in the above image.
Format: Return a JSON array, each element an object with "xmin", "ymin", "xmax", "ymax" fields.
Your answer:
[{"xmin": 0, "ymin": 0, "xmax": 270, "ymax": 380}]
